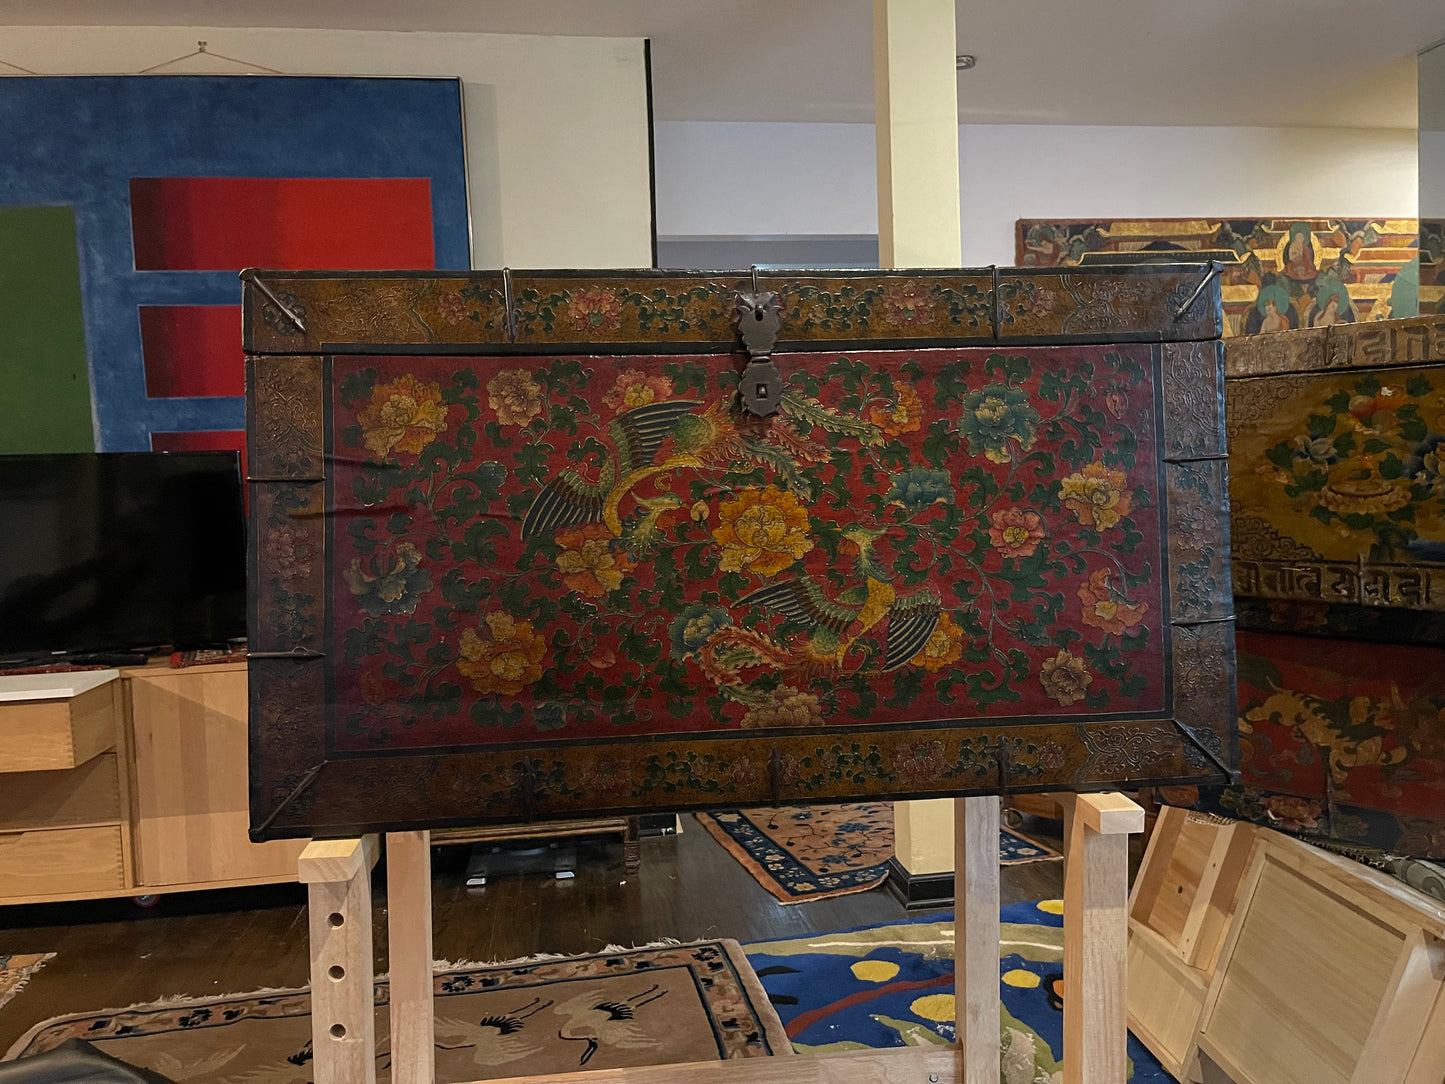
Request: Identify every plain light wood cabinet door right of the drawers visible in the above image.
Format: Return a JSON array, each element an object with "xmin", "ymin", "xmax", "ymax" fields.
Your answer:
[{"xmin": 130, "ymin": 665, "xmax": 305, "ymax": 886}]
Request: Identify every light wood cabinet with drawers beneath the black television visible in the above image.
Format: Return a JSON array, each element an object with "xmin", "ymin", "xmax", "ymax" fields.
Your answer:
[{"xmin": 0, "ymin": 663, "xmax": 306, "ymax": 905}]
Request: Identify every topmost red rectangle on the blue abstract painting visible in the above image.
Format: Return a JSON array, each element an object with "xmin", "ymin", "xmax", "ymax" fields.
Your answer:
[{"xmin": 130, "ymin": 176, "xmax": 436, "ymax": 270}]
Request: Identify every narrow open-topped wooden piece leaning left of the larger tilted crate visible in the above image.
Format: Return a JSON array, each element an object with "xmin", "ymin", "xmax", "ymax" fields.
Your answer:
[{"xmin": 1129, "ymin": 806, "xmax": 1254, "ymax": 1080}]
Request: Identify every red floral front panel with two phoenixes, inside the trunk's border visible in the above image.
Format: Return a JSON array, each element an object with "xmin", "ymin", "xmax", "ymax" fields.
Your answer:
[{"xmin": 329, "ymin": 345, "xmax": 1170, "ymax": 752}]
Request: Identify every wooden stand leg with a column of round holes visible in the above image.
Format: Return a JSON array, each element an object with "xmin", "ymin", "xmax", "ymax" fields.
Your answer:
[{"xmin": 296, "ymin": 835, "xmax": 376, "ymax": 1084}]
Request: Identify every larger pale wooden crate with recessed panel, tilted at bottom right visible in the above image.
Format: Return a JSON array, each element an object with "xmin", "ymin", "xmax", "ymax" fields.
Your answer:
[{"xmin": 1198, "ymin": 831, "xmax": 1445, "ymax": 1084}]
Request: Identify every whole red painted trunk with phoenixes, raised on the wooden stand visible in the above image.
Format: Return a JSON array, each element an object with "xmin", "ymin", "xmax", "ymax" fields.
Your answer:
[{"xmin": 244, "ymin": 266, "xmax": 1235, "ymax": 838}]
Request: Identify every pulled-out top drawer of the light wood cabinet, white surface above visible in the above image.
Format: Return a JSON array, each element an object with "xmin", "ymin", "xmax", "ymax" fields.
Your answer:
[{"xmin": 0, "ymin": 682, "xmax": 118, "ymax": 772}]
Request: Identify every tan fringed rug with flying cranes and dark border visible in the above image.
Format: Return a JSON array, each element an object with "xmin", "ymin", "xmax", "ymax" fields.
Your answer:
[{"xmin": 6, "ymin": 939, "xmax": 792, "ymax": 1084}]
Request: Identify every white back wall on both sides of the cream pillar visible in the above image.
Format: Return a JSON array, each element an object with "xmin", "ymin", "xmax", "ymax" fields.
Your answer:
[{"xmin": 656, "ymin": 121, "xmax": 1418, "ymax": 266}]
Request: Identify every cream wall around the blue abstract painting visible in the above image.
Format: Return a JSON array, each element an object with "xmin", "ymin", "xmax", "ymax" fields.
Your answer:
[{"xmin": 3, "ymin": 26, "xmax": 652, "ymax": 267}]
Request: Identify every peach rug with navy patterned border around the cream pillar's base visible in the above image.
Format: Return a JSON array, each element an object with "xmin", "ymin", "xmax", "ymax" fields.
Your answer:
[{"xmin": 696, "ymin": 802, "xmax": 1059, "ymax": 903}]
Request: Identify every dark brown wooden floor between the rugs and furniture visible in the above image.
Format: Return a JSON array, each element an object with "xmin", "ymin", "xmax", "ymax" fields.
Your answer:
[{"xmin": 0, "ymin": 817, "xmax": 1080, "ymax": 1052}]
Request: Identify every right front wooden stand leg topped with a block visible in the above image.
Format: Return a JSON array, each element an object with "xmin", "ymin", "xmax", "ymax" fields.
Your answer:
[{"xmin": 1059, "ymin": 793, "xmax": 1144, "ymax": 1084}]
